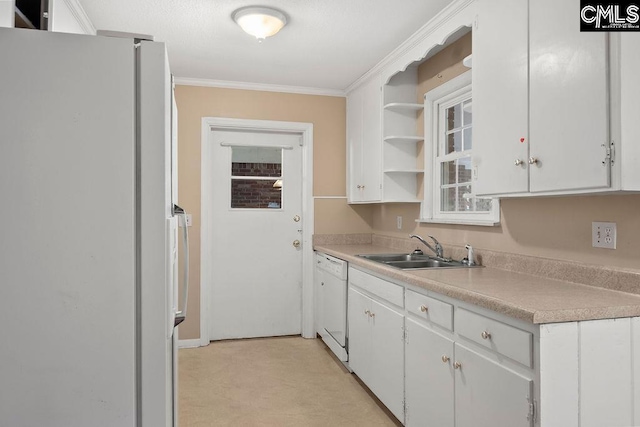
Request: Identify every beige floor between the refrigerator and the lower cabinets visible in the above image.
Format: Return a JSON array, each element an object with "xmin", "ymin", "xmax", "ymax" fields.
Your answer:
[{"xmin": 178, "ymin": 337, "xmax": 401, "ymax": 427}]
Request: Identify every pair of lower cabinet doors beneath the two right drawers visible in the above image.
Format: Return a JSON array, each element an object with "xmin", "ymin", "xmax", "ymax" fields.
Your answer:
[{"xmin": 405, "ymin": 319, "xmax": 533, "ymax": 427}]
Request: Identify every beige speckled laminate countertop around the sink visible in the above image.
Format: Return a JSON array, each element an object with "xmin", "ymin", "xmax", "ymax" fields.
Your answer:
[{"xmin": 314, "ymin": 245, "xmax": 640, "ymax": 324}]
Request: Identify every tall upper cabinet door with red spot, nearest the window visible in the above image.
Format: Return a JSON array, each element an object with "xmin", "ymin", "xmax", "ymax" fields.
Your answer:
[{"xmin": 472, "ymin": 0, "xmax": 528, "ymax": 195}]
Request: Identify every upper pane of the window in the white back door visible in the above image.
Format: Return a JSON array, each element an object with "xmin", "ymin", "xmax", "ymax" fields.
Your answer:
[{"xmin": 231, "ymin": 147, "xmax": 282, "ymax": 177}]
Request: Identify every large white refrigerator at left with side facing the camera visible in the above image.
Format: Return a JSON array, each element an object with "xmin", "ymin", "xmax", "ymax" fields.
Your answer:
[{"xmin": 0, "ymin": 28, "xmax": 188, "ymax": 427}]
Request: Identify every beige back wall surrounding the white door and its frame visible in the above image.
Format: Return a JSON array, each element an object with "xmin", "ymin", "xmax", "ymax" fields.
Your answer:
[{"xmin": 176, "ymin": 86, "xmax": 364, "ymax": 339}]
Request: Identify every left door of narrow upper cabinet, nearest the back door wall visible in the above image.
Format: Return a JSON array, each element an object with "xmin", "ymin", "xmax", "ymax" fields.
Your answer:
[{"xmin": 347, "ymin": 87, "xmax": 363, "ymax": 203}]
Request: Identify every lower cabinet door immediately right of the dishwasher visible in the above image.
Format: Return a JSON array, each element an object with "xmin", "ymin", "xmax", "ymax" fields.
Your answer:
[{"xmin": 348, "ymin": 288, "xmax": 371, "ymax": 385}]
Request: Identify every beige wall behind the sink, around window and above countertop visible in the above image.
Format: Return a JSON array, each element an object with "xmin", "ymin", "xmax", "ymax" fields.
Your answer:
[{"xmin": 372, "ymin": 34, "xmax": 640, "ymax": 269}]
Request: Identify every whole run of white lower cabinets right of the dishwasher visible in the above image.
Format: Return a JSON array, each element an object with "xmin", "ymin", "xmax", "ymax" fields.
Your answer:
[{"xmin": 348, "ymin": 267, "xmax": 640, "ymax": 427}]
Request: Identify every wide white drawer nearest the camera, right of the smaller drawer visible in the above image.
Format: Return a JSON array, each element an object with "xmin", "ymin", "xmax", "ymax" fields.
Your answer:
[{"xmin": 455, "ymin": 308, "xmax": 533, "ymax": 367}]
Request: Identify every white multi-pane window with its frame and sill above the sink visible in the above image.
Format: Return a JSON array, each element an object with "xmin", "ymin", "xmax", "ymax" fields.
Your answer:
[{"xmin": 421, "ymin": 71, "xmax": 500, "ymax": 225}]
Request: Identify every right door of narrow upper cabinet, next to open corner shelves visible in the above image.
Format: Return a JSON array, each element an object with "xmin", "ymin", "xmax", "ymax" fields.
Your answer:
[{"xmin": 361, "ymin": 77, "xmax": 382, "ymax": 202}]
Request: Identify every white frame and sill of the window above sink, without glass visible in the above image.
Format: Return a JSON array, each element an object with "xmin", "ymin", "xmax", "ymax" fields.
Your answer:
[{"xmin": 418, "ymin": 70, "xmax": 500, "ymax": 226}]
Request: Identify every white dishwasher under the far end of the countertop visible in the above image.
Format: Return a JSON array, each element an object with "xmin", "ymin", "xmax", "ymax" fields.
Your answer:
[{"xmin": 316, "ymin": 253, "xmax": 349, "ymax": 365}]
